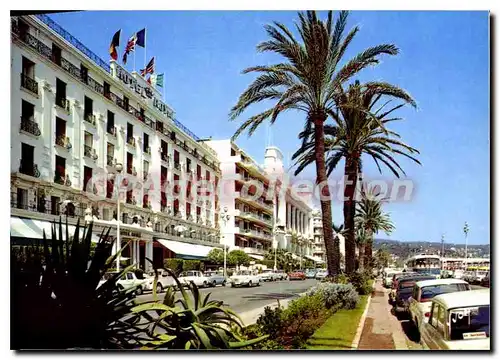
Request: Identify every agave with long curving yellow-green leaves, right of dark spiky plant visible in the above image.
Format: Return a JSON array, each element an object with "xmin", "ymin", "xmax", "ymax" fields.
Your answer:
[{"xmin": 132, "ymin": 269, "xmax": 267, "ymax": 350}]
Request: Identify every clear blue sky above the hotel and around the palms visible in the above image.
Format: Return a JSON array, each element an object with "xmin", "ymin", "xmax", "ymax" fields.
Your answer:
[{"xmin": 51, "ymin": 11, "xmax": 490, "ymax": 244}]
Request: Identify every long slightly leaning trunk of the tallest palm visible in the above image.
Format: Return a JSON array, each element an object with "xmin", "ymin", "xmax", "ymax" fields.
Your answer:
[{"xmin": 311, "ymin": 114, "xmax": 340, "ymax": 276}]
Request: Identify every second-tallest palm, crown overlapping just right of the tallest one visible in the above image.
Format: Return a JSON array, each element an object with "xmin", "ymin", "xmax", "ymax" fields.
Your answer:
[{"xmin": 292, "ymin": 81, "xmax": 420, "ymax": 274}]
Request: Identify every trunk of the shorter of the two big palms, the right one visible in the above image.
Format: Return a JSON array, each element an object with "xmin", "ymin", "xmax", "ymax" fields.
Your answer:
[{"xmin": 344, "ymin": 155, "xmax": 361, "ymax": 275}]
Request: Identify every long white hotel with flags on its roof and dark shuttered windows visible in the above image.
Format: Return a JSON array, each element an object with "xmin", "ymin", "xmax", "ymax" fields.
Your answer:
[{"xmin": 11, "ymin": 15, "xmax": 225, "ymax": 269}]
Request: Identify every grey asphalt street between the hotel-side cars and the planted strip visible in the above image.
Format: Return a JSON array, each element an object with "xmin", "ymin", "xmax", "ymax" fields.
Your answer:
[{"xmin": 137, "ymin": 279, "xmax": 318, "ymax": 313}]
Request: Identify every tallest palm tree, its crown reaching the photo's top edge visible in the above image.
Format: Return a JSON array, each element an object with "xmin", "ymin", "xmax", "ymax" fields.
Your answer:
[{"xmin": 229, "ymin": 11, "xmax": 398, "ymax": 275}]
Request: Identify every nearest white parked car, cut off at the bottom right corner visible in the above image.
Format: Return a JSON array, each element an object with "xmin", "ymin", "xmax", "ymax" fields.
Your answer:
[{"xmin": 420, "ymin": 289, "xmax": 490, "ymax": 350}]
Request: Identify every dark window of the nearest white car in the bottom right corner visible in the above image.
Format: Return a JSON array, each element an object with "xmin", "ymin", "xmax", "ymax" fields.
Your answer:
[{"xmin": 449, "ymin": 305, "xmax": 490, "ymax": 340}]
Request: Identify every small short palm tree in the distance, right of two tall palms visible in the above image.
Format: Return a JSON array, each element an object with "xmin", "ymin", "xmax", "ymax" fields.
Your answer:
[{"xmin": 355, "ymin": 192, "xmax": 395, "ymax": 266}]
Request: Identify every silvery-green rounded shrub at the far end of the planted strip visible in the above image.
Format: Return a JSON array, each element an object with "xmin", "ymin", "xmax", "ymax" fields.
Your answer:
[{"xmin": 307, "ymin": 283, "xmax": 359, "ymax": 309}]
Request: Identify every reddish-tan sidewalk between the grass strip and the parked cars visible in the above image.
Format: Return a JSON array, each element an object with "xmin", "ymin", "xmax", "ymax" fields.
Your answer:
[{"xmin": 358, "ymin": 281, "xmax": 408, "ymax": 350}]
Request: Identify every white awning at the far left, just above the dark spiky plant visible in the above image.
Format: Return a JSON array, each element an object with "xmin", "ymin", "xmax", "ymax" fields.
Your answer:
[{"xmin": 10, "ymin": 217, "xmax": 99, "ymax": 243}]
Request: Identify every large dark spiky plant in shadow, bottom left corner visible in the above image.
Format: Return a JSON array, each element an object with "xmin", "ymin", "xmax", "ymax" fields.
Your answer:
[{"xmin": 11, "ymin": 220, "xmax": 143, "ymax": 349}]
